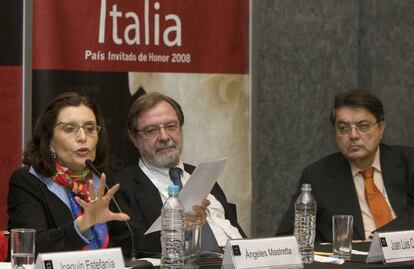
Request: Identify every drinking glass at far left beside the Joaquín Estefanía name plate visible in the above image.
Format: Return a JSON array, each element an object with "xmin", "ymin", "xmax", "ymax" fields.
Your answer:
[{"xmin": 10, "ymin": 228, "xmax": 36, "ymax": 269}]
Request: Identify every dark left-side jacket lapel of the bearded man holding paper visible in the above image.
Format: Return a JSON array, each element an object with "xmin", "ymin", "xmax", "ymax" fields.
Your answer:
[{"xmin": 131, "ymin": 165, "xmax": 162, "ymax": 227}]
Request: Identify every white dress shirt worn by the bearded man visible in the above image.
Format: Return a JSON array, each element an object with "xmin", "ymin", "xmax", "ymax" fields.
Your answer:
[{"xmin": 138, "ymin": 157, "xmax": 242, "ymax": 247}]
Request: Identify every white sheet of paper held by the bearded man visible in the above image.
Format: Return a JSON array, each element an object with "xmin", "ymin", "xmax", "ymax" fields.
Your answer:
[{"xmin": 145, "ymin": 159, "xmax": 227, "ymax": 234}]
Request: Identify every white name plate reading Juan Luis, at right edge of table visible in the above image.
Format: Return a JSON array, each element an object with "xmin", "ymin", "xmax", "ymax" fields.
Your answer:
[{"xmin": 366, "ymin": 230, "xmax": 414, "ymax": 263}]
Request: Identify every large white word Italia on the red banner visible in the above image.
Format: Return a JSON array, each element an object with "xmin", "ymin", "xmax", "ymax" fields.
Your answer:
[{"xmin": 98, "ymin": 0, "xmax": 182, "ymax": 47}]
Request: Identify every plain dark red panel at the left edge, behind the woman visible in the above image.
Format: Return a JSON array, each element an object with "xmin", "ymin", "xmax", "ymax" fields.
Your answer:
[{"xmin": 0, "ymin": 66, "xmax": 22, "ymax": 229}]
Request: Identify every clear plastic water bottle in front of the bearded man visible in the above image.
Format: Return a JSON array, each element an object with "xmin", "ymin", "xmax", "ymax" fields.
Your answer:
[{"xmin": 161, "ymin": 185, "xmax": 184, "ymax": 268}]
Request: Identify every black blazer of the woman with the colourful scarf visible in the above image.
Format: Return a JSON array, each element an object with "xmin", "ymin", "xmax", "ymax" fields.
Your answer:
[{"xmin": 8, "ymin": 167, "xmax": 90, "ymax": 255}]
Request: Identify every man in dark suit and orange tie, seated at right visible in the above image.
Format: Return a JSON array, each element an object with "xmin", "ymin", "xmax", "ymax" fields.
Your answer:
[{"xmin": 277, "ymin": 90, "xmax": 414, "ymax": 242}]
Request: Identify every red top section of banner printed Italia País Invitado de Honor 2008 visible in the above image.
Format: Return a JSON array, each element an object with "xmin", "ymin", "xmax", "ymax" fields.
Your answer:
[{"xmin": 33, "ymin": 0, "xmax": 249, "ymax": 74}]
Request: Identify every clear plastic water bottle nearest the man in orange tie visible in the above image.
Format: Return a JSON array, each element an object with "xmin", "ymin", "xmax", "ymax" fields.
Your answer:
[{"xmin": 294, "ymin": 184, "xmax": 317, "ymax": 263}]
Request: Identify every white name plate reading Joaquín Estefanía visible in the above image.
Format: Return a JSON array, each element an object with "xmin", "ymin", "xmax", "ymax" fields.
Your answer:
[{"xmin": 36, "ymin": 248, "xmax": 125, "ymax": 269}]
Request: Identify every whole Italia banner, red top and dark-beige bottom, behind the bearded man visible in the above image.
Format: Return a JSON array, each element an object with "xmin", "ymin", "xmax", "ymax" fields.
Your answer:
[{"xmin": 32, "ymin": 0, "xmax": 250, "ymax": 230}]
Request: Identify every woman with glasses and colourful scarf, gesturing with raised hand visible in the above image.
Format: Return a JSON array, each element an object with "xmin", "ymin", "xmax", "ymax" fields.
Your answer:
[{"xmin": 8, "ymin": 92, "xmax": 129, "ymax": 253}]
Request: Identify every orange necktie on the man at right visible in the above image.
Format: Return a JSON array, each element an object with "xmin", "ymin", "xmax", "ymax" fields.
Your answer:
[{"xmin": 361, "ymin": 167, "xmax": 393, "ymax": 228}]
